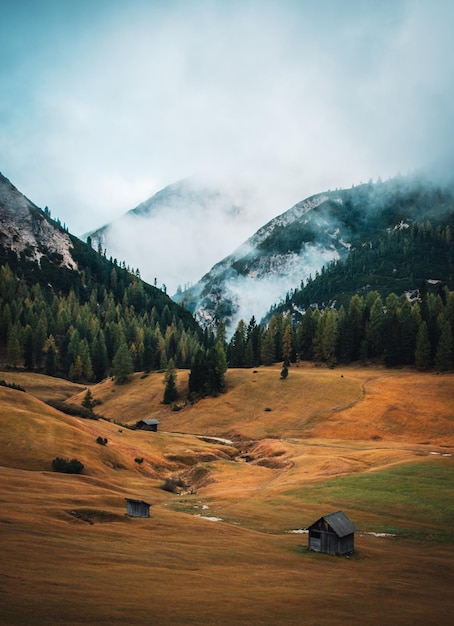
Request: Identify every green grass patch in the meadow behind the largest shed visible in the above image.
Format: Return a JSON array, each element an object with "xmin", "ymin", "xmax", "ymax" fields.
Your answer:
[{"xmin": 285, "ymin": 459, "xmax": 454, "ymax": 543}]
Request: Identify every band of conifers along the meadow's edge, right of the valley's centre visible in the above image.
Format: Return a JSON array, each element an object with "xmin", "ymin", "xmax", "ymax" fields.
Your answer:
[{"xmin": 227, "ymin": 282, "xmax": 454, "ymax": 371}]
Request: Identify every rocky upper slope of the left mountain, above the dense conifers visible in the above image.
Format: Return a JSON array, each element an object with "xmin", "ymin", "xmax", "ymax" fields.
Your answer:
[{"xmin": 0, "ymin": 169, "xmax": 200, "ymax": 338}]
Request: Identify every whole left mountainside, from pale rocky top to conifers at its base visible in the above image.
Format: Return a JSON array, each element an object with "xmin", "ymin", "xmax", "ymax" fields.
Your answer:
[{"xmin": 0, "ymin": 176, "xmax": 203, "ymax": 382}]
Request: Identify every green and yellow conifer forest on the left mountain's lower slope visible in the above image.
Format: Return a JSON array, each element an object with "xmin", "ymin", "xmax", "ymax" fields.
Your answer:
[{"xmin": 0, "ymin": 265, "xmax": 212, "ymax": 382}]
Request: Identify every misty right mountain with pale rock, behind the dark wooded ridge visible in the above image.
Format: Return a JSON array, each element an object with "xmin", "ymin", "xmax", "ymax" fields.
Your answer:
[{"xmin": 175, "ymin": 177, "xmax": 454, "ymax": 330}]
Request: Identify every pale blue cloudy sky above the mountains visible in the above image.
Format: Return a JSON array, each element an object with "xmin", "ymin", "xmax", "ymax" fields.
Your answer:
[{"xmin": 0, "ymin": 0, "xmax": 454, "ymax": 286}]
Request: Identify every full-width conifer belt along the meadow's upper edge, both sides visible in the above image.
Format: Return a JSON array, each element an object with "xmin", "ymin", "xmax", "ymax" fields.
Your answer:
[{"xmin": 0, "ymin": 265, "xmax": 454, "ymax": 403}]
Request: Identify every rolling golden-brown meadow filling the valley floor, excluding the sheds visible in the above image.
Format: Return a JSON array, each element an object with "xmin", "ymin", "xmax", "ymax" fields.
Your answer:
[{"xmin": 0, "ymin": 364, "xmax": 454, "ymax": 626}]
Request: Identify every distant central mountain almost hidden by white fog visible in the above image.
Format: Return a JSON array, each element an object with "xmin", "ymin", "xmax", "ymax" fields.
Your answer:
[{"xmin": 84, "ymin": 179, "xmax": 254, "ymax": 294}]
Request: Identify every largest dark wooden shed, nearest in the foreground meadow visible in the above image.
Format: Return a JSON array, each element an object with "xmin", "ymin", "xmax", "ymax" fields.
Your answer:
[{"xmin": 307, "ymin": 511, "xmax": 358, "ymax": 554}]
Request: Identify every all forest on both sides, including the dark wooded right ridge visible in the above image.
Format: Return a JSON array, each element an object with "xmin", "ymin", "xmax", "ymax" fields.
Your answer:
[{"xmin": 0, "ymin": 201, "xmax": 454, "ymax": 394}]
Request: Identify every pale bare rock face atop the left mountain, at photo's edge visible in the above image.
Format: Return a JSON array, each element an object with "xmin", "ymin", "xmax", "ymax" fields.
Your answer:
[{"xmin": 0, "ymin": 174, "xmax": 77, "ymax": 269}]
